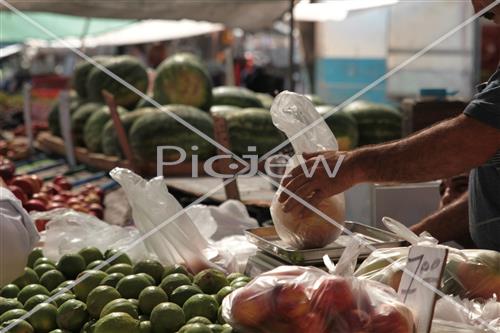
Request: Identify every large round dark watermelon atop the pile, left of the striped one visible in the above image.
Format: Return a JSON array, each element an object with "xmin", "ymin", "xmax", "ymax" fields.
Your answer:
[{"xmin": 86, "ymin": 56, "xmax": 148, "ymax": 108}]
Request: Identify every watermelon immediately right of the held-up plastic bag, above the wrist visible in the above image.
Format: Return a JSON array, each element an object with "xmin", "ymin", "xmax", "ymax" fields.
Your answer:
[{"xmin": 316, "ymin": 105, "xmax": 359, "ymax": 150}]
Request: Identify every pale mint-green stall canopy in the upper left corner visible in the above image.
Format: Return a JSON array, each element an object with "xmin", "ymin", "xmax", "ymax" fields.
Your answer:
[{"xmin": 0, "ymin": 11, "xmax": 136, "ymax": 43}]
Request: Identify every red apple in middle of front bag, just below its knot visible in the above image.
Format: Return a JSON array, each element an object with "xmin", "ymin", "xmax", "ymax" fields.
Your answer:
[{"xmin": 311, "ymin": 276, "xmax": 356, "ymax": 317}]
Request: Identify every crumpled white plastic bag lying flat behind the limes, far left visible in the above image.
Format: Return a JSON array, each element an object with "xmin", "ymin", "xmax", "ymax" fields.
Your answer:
[{"xmin": 31, "ymin": 208, "xmax": 152, "ymax": 261}]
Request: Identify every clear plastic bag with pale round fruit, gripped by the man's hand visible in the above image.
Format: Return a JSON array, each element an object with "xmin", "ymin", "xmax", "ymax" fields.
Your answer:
[{"xmin": 271, "ymin": 91, "xmax": 345, "ymax": 249}]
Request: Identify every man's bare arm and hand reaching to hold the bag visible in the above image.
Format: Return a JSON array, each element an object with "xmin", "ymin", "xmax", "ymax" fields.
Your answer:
[{"xmin": 279, "ymin": 115, "xmax": 500, "ymax": 211}]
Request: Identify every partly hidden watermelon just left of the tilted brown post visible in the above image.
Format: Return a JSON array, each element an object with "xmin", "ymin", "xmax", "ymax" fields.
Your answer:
[{"xmin": 83, "ymin": 105, "xmax": 127, "ymax": 153}]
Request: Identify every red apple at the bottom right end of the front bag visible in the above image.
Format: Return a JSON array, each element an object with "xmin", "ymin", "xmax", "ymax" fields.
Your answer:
[{"xmin": 369, "ymin": 304, "xmax": 413, "ymax": 333}]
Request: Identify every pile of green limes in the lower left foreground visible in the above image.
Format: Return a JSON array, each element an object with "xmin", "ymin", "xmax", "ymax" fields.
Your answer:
[{"xmin": 0, "ymin": 247, "xmax": 250, "ymax": 333}]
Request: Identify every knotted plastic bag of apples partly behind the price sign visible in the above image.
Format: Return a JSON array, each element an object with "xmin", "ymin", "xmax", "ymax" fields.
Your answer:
[{"xmin": 354, "ymin": 217, "xmax": 500, "ymax": 299}]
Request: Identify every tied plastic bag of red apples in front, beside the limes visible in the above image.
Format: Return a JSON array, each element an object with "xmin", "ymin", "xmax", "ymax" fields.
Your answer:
[{"xmin": 222, "ymin": 237, "xmax": 414, "ymax": 333}]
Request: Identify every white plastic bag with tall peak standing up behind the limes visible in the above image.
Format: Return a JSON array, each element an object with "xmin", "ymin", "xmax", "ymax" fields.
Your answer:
[{"xmin": 110, "ymin": 168, "xmax": 235, "ymax": 273}]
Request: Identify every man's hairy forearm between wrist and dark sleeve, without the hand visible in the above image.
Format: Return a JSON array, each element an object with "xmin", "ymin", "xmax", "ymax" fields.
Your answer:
[{"xmin": 347, "ymin": 115, "xmax": 500, "ymax": 183}]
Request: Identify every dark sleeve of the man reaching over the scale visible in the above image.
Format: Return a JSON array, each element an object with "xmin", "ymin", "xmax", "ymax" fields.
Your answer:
[{"xmin": 464, "ymin": 82, "xmax": 500, "ymax": 129}]
